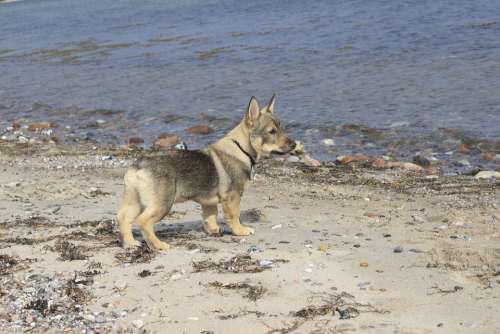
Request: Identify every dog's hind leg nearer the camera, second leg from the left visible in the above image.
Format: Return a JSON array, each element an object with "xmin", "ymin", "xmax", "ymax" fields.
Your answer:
[{"xmin": 137, "ymin": 180, "xmax": 175, "ymax": 251}]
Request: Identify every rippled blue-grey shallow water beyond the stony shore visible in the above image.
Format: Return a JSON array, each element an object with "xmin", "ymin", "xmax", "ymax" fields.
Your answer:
[{"xmin": 0, "ymin": 0, "xmax": 500, "ymax": 164}]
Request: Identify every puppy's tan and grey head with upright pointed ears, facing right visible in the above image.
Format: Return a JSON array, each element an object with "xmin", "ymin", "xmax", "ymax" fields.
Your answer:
[{"xmin": 244, "ymin": 95, "xmax": 295, "ymax": 156}]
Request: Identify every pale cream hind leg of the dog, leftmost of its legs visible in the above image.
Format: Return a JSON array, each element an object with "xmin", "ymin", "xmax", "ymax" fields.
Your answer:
[{"xmin": 116, "ymin": 174, "xmax": 142, "ymax": 248}]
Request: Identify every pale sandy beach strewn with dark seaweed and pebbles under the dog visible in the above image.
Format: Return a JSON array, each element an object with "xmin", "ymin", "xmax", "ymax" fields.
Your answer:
[{"xmin": 0, "ymin": 143, "xmax": 500, "ymax": 333}]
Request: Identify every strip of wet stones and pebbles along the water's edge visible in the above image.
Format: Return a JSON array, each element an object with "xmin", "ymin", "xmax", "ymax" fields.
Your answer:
[{"xmin": 0, "ymin": 119, "xmax": 500, "ymax": 176}]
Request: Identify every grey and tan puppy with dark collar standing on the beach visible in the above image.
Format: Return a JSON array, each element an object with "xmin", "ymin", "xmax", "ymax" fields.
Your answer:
[{"xmin": 117, "ymin": 95, "xmax": 296, "ymax": 251}]
